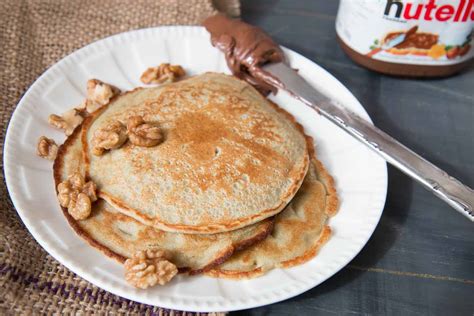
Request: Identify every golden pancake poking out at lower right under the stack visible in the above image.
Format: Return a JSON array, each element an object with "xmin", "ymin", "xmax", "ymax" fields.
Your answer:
[{"xmin": 206, "ymin": 144, "xmax": 339, "ymax": 279}]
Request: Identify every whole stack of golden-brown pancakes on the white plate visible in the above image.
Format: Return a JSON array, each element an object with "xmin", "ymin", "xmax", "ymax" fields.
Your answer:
[{"xmin": 54, "ymin": 73, "xmax": 338, "ymax": 279}]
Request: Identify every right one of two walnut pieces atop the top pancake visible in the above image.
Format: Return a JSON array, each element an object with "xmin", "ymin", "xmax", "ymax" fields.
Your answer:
[{"xmin": 127, "ymin": 116, "xmax": 163, "ymax": 147}]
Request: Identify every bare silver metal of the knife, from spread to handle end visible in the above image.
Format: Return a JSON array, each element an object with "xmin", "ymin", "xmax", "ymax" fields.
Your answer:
[{"xmin": 253, "ymin": 63, "xmax": 474, "ymax": 221}]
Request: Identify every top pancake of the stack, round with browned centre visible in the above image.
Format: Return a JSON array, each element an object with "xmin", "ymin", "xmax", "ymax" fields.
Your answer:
[{"xmin": 82, "ymin": 73, "xmax": 309, "ymax": 233}]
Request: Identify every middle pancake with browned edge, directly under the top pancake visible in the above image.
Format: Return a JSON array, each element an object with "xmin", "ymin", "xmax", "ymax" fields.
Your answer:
[{"xmin": 54, "ymin": 128, "xmax": 273, "ymax": 274}]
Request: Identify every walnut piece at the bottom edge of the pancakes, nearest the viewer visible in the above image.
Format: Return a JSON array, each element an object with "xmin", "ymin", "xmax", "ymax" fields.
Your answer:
[{"xmin": 125, "ymin": 250, "xmax": 178, "ymax": 289}]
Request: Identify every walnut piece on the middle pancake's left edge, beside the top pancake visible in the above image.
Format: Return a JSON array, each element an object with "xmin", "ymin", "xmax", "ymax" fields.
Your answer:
[{"xmin": 57, "ymin": 172, "xmax": 97, "ymax": 220}]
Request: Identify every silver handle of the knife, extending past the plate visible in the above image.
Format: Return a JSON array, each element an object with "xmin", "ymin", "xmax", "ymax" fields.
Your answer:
[{"xmin": 314, "ymin": 96, "xmax": 474, "ymax": 221}]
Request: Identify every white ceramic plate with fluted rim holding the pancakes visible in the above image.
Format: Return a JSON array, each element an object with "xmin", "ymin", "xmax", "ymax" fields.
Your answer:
[{"xmin": 4, "ymin": 26, "xmax": 387, "ymax": 311}]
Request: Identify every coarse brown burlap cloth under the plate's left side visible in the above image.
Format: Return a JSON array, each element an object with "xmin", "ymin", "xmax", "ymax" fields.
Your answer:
[{"xmin": 0, "ymin": 0, "xmax": 239, "ymax": 315}]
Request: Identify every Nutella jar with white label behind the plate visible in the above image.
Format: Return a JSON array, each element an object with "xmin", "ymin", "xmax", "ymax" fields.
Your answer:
[{"xmin": 336, "ymin": 0, "xmax": 474, "ymax": 77}]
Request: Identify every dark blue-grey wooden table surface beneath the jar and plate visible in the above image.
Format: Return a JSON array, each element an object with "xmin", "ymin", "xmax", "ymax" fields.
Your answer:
[{"xmin": 234, "ymin": 0, "xmax": 474, "ymax": 315}]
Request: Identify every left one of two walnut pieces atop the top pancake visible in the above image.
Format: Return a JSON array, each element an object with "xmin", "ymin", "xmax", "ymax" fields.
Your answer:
[{"xmin": 92, "ymin": 121, "xmax": 127, "ymax": 156}]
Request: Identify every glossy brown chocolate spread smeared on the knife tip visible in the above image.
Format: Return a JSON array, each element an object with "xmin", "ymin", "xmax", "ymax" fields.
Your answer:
[{"xmin": 202, "ymin": 14, "xmax": 285, "ymax": 95}]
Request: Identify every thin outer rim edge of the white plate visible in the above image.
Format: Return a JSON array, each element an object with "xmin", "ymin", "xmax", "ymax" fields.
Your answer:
[{"xmin": 3, "ymin": 25, "xmax": 388, "ymax": 312}]
